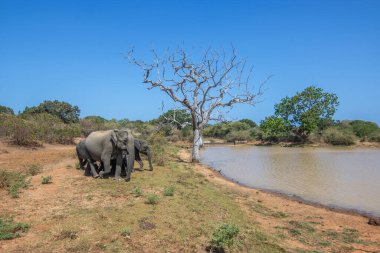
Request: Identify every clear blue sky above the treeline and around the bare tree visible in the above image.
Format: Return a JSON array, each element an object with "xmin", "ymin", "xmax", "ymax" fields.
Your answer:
[{"xmin": 0, "ymin": 0, "xmax": 380, "ymax": 123}]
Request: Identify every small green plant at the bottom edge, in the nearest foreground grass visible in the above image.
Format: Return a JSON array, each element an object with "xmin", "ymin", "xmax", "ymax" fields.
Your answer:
[{"xmin": 210, "ymin": 224, "xmax": 239, "ymax": 249}]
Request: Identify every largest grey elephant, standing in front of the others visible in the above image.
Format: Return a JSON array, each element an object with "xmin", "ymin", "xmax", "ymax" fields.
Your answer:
[{"xmin": 85, "ymin": 129, "xmax": 135, "ymax": 181}]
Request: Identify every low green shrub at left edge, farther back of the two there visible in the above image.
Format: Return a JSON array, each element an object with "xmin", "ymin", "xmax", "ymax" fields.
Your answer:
[{"xmin": 0, "ymin": 170, "xmax": 30, "ymax": 198}]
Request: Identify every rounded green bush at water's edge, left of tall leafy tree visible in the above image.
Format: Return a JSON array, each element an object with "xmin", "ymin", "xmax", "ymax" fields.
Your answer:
[{"xmin": 260, "ymin": 116, "xmax": 290, "ymax": 141}]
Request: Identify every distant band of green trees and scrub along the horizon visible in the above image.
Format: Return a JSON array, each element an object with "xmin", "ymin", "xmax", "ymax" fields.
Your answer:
[{"xmin": 0, "ymin": 86, "xmax": 380, "ymax": 145}]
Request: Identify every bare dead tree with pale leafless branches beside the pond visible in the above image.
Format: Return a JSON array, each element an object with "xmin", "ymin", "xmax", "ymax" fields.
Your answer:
[{"xmin": 128, "ymin": 48, "xmax": 263, "ymax": 162}]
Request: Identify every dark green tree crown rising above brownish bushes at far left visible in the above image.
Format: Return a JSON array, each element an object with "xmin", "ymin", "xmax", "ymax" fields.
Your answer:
[{"xmin": 22, "ymin": 100, "xmax": 80, "ymax": 123}]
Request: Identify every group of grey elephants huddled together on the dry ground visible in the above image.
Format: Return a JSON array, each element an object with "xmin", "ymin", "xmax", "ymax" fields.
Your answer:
[{"xmin": 76, "ymin": 129, "xmax": 153, "ymax": 181}]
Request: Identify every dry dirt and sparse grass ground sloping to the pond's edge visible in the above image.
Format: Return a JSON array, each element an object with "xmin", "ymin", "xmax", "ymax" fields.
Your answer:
[{"xmin": 0, "ymin": 143, "xmax": 380, "ymax": 252}]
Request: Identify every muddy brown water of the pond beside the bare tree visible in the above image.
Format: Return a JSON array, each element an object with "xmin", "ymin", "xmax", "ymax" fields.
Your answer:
[{"xmin": 201, "ymin": 146, "xmax": 380, "ymax": 217}]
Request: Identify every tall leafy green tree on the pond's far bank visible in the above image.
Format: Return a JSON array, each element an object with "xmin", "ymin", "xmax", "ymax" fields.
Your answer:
[{"xmin": 275, "ymin": 86, "xmax": 339, "ymax": 139}]
